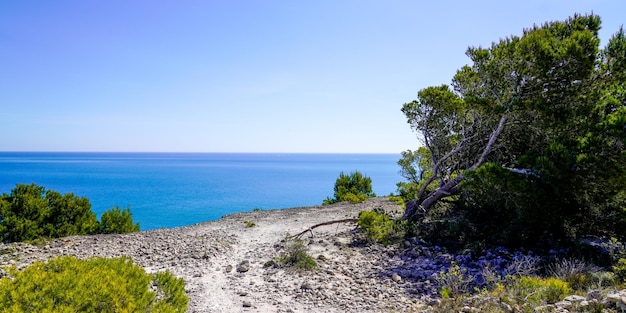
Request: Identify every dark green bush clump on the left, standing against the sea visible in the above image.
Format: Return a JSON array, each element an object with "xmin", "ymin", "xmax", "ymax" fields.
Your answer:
[{"xmin": 0, "ymin": 184, "xmax": 139, "ymax": 242}]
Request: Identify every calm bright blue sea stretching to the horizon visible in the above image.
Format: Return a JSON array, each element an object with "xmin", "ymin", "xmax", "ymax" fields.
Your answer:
[{"xmin": 0, "ymin": 152, "xmax": 402, "ymax": 230}]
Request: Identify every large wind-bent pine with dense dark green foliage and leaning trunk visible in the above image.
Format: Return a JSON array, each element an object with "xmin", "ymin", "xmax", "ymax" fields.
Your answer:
[{"xmin": 399, "ymin": 15, "xmax": 626, "ymax": 245}]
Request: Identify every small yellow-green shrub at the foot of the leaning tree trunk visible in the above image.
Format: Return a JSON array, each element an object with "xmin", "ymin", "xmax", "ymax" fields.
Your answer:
[{"xmin": 358, "ymin": 209, "xmax": 407, "ymax": 245}]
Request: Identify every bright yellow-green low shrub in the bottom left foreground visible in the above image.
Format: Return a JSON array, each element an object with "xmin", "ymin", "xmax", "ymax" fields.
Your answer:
[{"xmin": 0, "ymin": 256, "xmax": 189, "ymax": 312}]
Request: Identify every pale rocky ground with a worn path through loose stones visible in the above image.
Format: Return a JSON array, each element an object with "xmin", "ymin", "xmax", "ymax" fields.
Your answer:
[{"xmin": 0, "ymin": 198, "xmax": 429, "ymax": 312}]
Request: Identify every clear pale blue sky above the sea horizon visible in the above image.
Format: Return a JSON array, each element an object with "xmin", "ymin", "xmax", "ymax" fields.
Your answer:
[{"xmin": 0, "ymin": 0, "xmax": 626, "ymax": 153}]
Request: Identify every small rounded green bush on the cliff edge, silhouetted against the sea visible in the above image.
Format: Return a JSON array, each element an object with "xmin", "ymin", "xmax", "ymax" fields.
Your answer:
[{"xmin": 322, "ymin": 171, "xmax": 376, "ymax": 205}]
